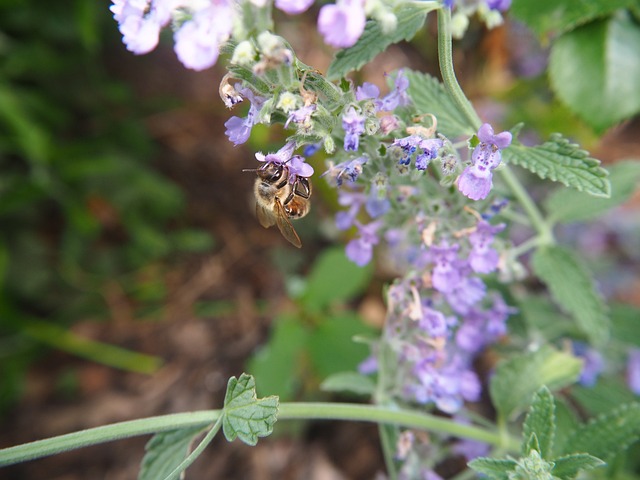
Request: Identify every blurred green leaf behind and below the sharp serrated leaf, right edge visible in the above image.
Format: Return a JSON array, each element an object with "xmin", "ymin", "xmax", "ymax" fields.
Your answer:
[{"xmin": 544, "ymin": 160, "xmax": 640, "ymax": 223}]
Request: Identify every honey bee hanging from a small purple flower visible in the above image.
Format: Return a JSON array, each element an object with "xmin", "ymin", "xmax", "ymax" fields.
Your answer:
[{"xmin": 253, "ymin": 163, "xmax": 311, "ymax": 248}]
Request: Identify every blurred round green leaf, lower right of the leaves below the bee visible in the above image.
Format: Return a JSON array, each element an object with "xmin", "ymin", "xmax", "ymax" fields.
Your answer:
[{"xmin": 307, "ymin": 312, "xmax": 373, "ymax": 378}]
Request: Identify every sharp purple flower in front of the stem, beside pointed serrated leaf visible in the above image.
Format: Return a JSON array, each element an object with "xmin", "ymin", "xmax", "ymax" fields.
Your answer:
[{"xmin": 458, "ymin": 123, "xmax": 511, "ymax": 200}]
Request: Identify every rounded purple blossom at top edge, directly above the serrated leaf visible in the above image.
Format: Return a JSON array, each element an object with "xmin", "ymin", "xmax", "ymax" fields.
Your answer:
[{"xmin": 318, "ymin": 0, "xmax": 366, "ymax": 48}]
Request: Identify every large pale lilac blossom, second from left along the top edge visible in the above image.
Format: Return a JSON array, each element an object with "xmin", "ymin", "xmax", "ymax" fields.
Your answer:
[{"xmin": 173, "ymin": 0, "xmax": 235, "ymax": 71}]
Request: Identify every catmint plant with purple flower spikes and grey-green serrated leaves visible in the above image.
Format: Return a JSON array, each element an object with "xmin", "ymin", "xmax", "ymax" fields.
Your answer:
[{"xmin": 0, "ymin": 0, "xmax": 640, "ymax": 479}]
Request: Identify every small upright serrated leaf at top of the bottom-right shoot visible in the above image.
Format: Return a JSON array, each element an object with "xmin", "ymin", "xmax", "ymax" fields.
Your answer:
[{"xmin": 522, "ymin": 386, "xmax": 556, "ymax": 458}]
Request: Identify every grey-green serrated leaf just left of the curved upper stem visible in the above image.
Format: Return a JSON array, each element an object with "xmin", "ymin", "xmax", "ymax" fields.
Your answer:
[{"xmin": 405, "ymin": 69, "xmax": 477, "ymax": 139}]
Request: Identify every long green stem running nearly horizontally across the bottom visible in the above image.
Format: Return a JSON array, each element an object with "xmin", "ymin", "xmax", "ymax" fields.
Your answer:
[{"xmin": 0, "ymin": 403, "xmax": 519, "ymax": 466}]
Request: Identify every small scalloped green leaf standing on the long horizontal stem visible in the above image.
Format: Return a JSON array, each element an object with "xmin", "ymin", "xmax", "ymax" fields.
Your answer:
[{"xmin": 222, "ymin": 373, "xmax": 278, "ymax": 446}]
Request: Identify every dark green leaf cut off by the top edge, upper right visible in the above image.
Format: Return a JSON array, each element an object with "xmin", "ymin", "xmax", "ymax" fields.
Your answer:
[{"xmin": 509, "ymin": 0, "xmax": 635, "ymax": 37}]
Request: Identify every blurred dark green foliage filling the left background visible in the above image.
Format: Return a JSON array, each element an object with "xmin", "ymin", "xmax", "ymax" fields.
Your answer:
[{"xmin": 0, "ymin": 0, "xmax": 211, "ymax": 409}]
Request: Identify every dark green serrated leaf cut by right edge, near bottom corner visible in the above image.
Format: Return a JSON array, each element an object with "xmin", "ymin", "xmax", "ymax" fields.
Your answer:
[{"xmin": 564, "ymin": 403, "xmax": 640, "ymax": 460}]
